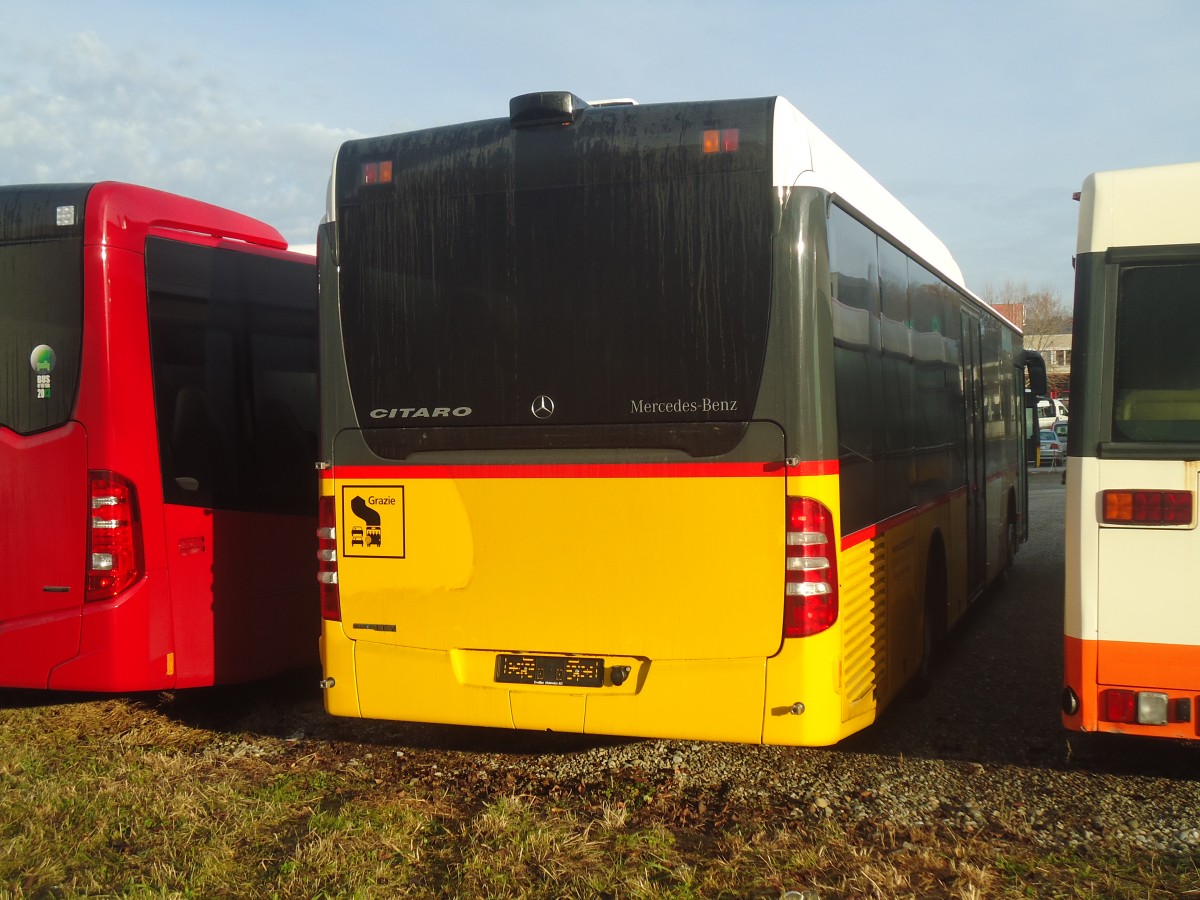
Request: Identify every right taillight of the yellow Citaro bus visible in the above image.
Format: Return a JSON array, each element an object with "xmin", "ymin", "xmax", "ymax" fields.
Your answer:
[{"xmin": 784, "ymin": 497, "xmax": 838, "ymax": 637}]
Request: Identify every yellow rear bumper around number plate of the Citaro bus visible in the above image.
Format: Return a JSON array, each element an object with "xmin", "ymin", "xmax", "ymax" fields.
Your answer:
[{"xmin": 320, "ymin": 623, "xmax": 874, "ymax": 745}]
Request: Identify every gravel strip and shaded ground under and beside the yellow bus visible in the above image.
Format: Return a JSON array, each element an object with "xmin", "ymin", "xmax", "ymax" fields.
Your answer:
[{"xmin": 201, "ymin": 474, "xmax": 1200, "ymax": 859}]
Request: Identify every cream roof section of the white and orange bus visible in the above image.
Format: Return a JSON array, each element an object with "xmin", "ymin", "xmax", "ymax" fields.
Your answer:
[{"xmin": 1075, "ymin": 162, "xmax": 1200, "ymax": 253}]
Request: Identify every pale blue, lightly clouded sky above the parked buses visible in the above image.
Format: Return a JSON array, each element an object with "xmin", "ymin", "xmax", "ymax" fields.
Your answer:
[{"xmin": 0, "ymin": 0, "xmax": 1200, "ymax": 302}]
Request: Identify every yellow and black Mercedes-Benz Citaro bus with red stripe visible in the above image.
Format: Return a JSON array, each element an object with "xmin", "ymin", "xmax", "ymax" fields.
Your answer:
[{"xmin": 318, "ymin": 92, "xmax": 1044, "ymax": 744}]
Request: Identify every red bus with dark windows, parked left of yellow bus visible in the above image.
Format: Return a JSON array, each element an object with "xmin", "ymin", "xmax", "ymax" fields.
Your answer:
[{"xmin": 0, "ymin": 182, "xmax": 319, "ymax": 691}]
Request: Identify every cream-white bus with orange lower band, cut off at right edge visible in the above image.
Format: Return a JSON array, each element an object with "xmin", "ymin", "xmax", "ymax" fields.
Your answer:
[{"xmin": 1062, "ymin": 162, "xmax": 1200, "ymax": 739}]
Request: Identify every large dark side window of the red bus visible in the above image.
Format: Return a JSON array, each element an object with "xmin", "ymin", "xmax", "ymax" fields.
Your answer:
[{"xmin": 146, "ymin": 239, "xmax": 317, "ymax": 514}]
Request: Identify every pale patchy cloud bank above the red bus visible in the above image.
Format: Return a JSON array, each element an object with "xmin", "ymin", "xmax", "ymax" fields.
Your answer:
[{"xmin": 0, "ymin": 32, "xmax": 359, "ymax": 241}]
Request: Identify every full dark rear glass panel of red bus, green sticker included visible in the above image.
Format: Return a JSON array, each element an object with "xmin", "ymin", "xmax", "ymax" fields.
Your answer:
[{"xmin": 0, "ymin": 186, "xmax": 86, "ymax": 434}]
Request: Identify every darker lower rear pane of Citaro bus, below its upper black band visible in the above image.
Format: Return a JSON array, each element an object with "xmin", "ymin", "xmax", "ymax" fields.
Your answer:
[{"xmin": 342, "ymin": 176, "xmax": 770, "ymax": 426}]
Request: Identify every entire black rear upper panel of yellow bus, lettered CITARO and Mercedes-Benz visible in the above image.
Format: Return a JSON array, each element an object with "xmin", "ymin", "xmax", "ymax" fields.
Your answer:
[{"xmin": 338, "ymin": 102, "xmax": 779, "ymax": 427}]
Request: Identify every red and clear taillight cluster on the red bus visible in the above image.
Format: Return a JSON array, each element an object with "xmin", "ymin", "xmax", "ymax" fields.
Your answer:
[{"xmin": 84, "ymin": 472, "xmax": 145, "ymax": 600}]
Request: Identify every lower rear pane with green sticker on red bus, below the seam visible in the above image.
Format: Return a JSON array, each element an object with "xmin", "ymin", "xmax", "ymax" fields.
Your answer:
[{"xmin": 0, "ymin": 238, "xmax": 83, "ymax": 434}]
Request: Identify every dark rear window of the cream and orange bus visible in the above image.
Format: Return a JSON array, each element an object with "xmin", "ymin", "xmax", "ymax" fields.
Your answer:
[{"xmin": 1112, "ymin": 263, "xmax": 1200, "ymax": 443}]
